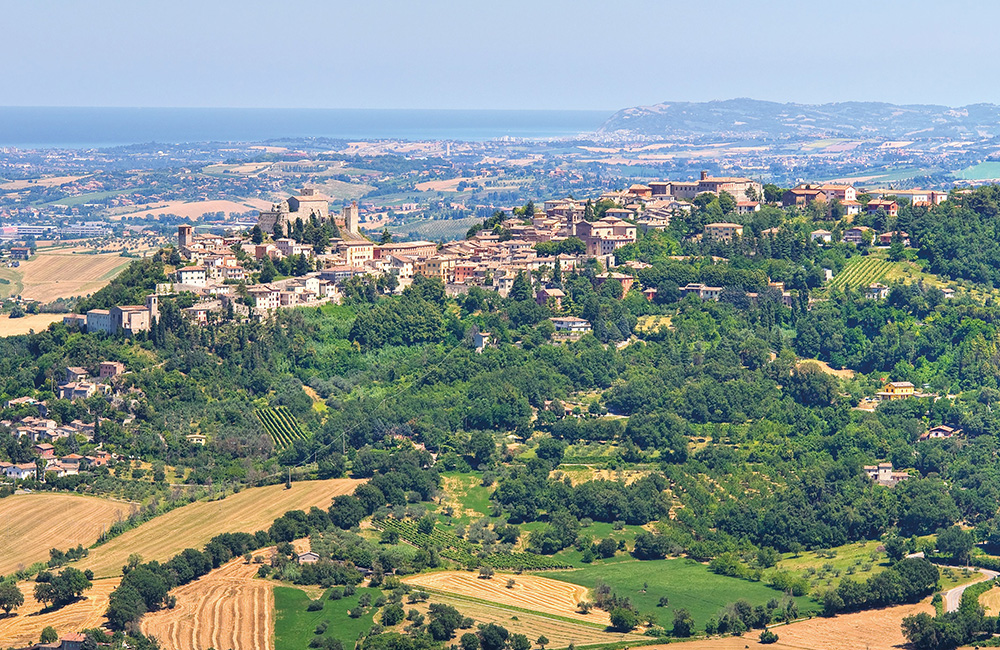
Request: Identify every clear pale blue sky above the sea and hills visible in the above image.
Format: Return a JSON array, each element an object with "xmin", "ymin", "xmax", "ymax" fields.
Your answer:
[{"xmin": 0, "ymin": 0, "xmax": 1000, "ymax": 109}]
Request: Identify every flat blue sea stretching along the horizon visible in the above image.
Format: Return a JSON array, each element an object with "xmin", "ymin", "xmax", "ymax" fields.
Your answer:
[{"xmin": 0, "ymin": 107, "xmax": 611, "ymax": 149}]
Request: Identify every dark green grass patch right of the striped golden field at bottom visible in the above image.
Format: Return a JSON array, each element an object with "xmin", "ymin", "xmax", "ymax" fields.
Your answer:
[{"xmin": 274, "ymin": 587, "xmax": 381, "ymax": 650}]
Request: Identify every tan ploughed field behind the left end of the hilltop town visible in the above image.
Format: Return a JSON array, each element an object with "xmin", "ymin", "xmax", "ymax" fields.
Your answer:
[{"xmin": 17, "ymin": 251, "xmax": 132, "ymax": 302}]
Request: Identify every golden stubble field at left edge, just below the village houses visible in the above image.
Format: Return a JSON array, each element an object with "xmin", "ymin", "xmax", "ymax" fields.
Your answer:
[{"xmin": 0, "ymin": 493, "xmax": 132, "ymax": 572}]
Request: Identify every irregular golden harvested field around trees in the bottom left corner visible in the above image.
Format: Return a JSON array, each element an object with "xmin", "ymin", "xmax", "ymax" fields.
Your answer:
[{"xmin": 0, "ymin": 578, "xmax": 120, "ymax": 646}]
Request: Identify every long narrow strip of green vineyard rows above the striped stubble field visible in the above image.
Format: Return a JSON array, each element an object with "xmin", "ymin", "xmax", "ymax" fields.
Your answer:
[{"xmin": 373, "ymin": 518, "xmax": 568, "ymax": 571}]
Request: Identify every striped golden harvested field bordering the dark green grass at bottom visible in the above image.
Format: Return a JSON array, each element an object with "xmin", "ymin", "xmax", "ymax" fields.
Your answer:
[{"xmin": 142, "ymin": 558, "xmax": 274, "ymax": 650}]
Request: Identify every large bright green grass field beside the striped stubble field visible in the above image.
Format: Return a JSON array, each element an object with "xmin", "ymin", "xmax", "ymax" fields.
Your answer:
[{"xmin": 545, "ymin": 559, "xmax": 819, "ymax": 628}]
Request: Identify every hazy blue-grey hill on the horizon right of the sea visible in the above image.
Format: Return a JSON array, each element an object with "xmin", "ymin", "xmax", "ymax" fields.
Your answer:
[{"xmin": 599, "ymin": 99, "xmax": 1000, "ymax": 140}]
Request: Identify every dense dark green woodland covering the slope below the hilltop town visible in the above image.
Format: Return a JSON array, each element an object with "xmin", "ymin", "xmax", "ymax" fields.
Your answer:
[{"xmin": 13, "ymin": 187, "xmax": 1000, "ymax": 648}]
